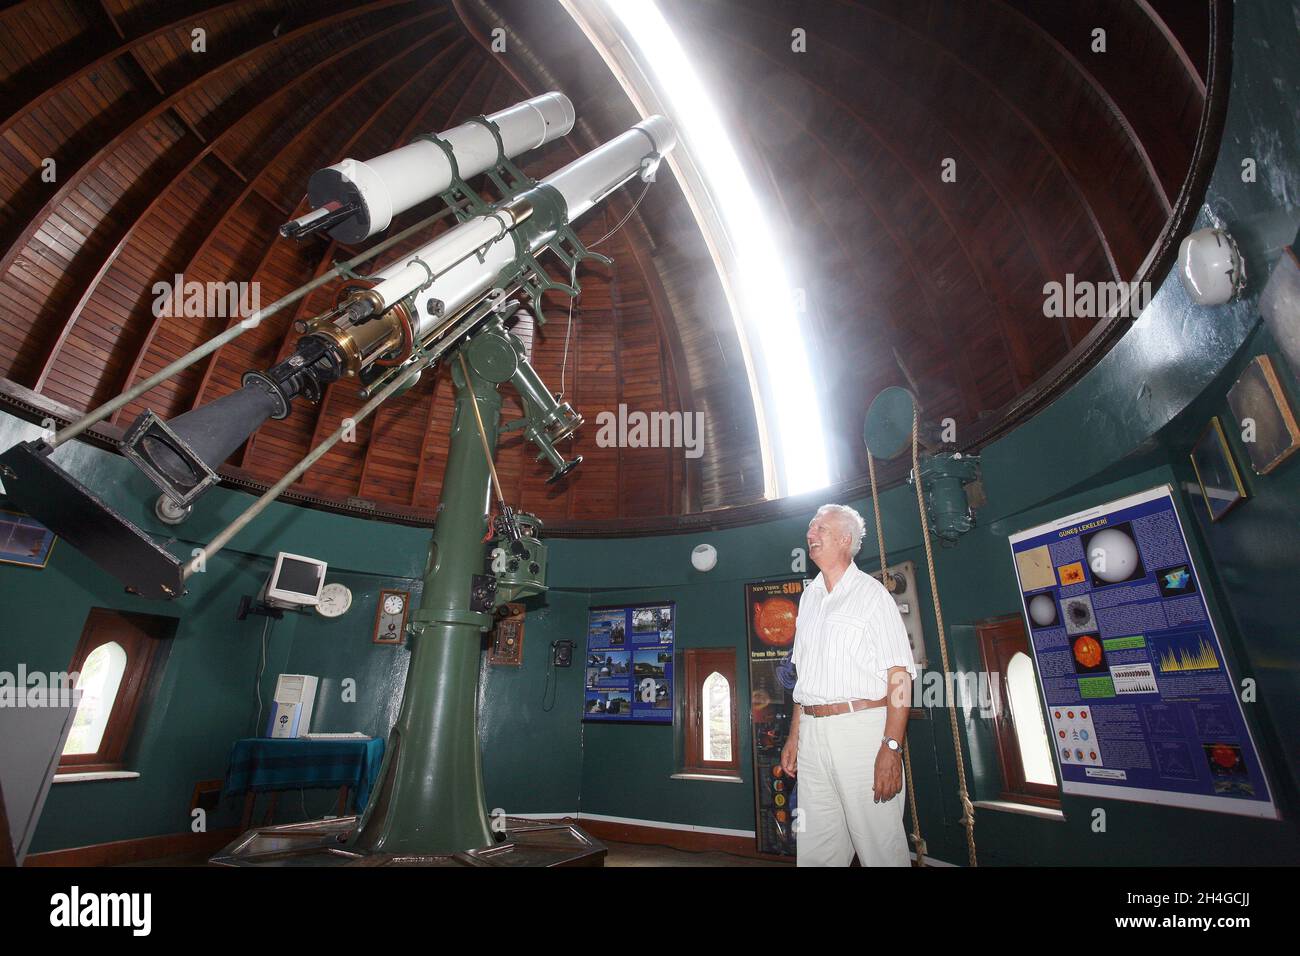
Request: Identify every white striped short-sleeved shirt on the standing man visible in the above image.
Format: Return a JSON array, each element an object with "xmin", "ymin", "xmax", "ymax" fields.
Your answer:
[{"xmin": 790, "ymin": 563, "xmax": 917, "ymax": 704}]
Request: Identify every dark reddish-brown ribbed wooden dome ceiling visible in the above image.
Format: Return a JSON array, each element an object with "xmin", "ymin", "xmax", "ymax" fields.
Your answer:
[{"xmin": 0, "ymin": 0, "xmax": 1214, "ymax": 531}]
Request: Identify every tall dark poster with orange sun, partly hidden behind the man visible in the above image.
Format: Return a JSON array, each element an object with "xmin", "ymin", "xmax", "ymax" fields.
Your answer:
[{"xmin": 745, "ymin": 578, "xmax": 805, "ymax": 856}]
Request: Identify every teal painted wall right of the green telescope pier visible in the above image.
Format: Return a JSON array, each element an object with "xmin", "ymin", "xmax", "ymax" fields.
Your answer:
[{"xmin": 441, "ymin": 4, "xmax": 1300, "ymax": 865}]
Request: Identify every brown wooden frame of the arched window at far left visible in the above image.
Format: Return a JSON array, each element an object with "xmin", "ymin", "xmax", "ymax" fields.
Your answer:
[{"xmin": 59, "ymin": 607, "xmax": 176, "ymax": 774}]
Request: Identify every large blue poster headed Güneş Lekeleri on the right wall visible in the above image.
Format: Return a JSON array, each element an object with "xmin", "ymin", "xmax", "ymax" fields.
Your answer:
[{"xmin": 1010, "ymin": 485, "xmax": 1278, "ymax": 818}]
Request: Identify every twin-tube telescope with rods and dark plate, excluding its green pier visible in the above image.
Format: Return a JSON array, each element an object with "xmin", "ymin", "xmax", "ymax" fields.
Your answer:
[{"xmin": 0, "ymin": 92, "xmax": 676, "ymax": 598}]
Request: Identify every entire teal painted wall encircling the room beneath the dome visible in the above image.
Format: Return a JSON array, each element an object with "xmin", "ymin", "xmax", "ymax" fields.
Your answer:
[{"xmin": 0, "ymin": 3, "xmax": 1300, "ymax": 865}]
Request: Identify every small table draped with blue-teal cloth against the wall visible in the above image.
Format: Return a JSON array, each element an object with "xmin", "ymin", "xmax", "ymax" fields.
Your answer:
[{"xmin": 225, "ymin": 737, "xmax": 384, "ymax": 830}]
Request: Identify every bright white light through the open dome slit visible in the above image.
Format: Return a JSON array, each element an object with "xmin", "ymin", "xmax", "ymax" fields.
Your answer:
[{"xmin": 606, "ymin": 0, "xmax": 829, "ymax": 494}]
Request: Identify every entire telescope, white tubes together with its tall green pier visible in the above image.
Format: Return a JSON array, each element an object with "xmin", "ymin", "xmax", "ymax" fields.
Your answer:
[{"xmin": 0, "ymin": 92, "xmax": 676, "ymax": 865}]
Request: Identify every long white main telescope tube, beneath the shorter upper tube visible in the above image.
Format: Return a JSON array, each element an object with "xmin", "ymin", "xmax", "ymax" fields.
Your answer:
[{"xmin": 373, "ymin": 116, "xmax": 677, "ymax": 338}]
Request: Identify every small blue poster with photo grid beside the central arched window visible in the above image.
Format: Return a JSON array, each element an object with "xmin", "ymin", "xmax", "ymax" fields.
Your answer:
[{"xmin": 582, "ymin": 601, "xmax": 677, "ymax": 723}]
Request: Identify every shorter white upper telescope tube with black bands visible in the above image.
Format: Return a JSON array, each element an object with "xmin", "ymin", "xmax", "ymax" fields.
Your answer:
[{"xmin": 302, "ymin": 92, "xmax": 575, "ymax": 242}]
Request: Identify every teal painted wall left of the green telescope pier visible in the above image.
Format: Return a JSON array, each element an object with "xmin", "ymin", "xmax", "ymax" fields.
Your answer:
[{"xmin": 0, "ymin": 415, "xmax": 429, "ymax": 853}]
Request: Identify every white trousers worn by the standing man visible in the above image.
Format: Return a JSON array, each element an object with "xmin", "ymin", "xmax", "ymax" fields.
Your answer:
[{"xmin": 796, "ymin": 708, "xmax": 911, "ymax": 866}]
